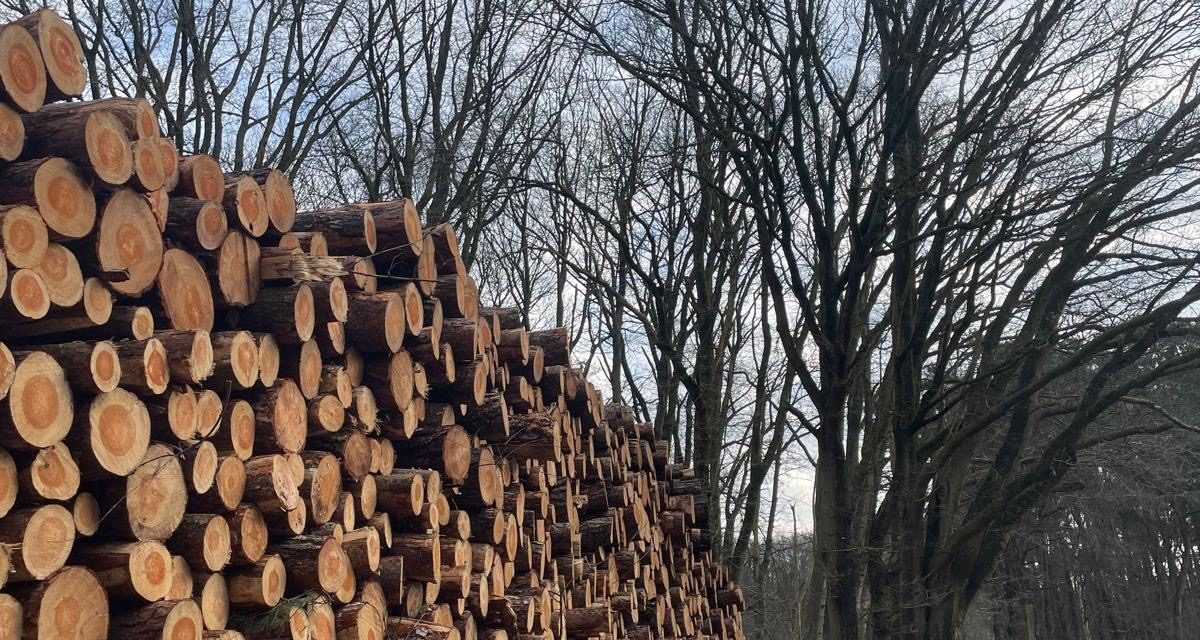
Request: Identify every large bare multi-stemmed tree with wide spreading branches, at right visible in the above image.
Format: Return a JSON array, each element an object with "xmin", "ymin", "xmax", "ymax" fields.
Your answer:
[{"xmin": 563, "ymin": 0, "xmax": 1200, "ymax": 638}]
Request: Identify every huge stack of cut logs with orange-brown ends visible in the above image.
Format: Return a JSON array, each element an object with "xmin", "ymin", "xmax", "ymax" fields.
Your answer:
[{"xmin": 0, "ymin": 10, "xmax": 743, "ymax": 640}]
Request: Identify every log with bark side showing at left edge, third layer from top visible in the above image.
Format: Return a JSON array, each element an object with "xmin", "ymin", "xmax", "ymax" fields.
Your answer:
[{"xmin": 0, "ymin": 156, "xmax": 96, "ymax": 239}]
